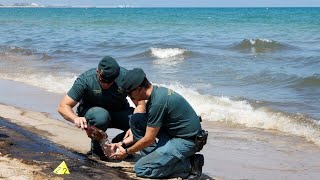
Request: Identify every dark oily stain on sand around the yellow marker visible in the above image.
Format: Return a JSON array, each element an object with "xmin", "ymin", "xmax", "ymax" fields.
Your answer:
[{"xmin": 0, "ymin": 118, "xmax": 129, "ymax": 179}]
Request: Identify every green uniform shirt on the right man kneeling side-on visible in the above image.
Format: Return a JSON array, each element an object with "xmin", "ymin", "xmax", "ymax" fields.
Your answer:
[{"xmin": 147, "ymin": 86, "xmax": 201, "ymax": 138}]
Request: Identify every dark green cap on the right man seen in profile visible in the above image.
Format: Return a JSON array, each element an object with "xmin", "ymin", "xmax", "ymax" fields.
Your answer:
[{"xmin": 121, "ymin": 68, "xmax": 146, "ymax": 92}]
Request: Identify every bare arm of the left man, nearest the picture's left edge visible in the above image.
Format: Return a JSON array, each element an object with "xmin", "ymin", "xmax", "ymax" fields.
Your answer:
[{"xmin": 58, "ymin": 95, "xmax": 87, "ymax": 129}]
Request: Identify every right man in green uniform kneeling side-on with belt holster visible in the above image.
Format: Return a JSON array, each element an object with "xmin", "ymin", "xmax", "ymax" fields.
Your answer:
[{"xmin": 112, "ymin": 68, "xmax": 207, "ymax": 179}]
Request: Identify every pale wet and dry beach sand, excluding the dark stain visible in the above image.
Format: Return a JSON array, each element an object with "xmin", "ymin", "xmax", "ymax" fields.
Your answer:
[{"xmin": 0, "ymin": 80, "xmax": 320, "ymax": 179}]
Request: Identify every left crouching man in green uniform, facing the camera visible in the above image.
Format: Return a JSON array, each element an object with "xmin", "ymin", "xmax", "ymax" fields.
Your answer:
[{"xmin": 58, "ymin": 56, "xmax": 133, "ymax": 158}]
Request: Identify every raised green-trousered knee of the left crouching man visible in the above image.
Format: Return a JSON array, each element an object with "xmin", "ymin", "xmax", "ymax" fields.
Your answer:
[{"xmin": 85, "ymin": 107, "xmax": 111, "ymax": 130}]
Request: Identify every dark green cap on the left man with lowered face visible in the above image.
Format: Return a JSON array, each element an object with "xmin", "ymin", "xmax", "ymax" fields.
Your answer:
[{"xmin": 98, "ymin": 56, "xmax": 120, "ymax": 82}]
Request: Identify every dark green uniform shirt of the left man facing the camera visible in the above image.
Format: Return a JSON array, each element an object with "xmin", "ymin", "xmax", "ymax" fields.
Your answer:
[{"xmin": 68, "ymin": 67, "xmax": 129, "ymax": 113}]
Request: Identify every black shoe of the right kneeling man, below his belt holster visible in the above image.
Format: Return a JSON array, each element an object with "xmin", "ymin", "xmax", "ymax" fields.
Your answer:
[{"xmin": 187, "ymin": 154, "xmax": 204, "ymax": 180}]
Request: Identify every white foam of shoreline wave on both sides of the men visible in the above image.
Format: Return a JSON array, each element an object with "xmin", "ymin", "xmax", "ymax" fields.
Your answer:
[{"xmin": 0, "ymin": 65, "xmax": 320, "ymax": 146}]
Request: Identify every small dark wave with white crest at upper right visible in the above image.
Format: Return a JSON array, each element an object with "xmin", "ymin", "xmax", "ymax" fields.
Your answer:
[{"xmin": 231, "ymin": 39, "xmax": 289, "ymax": 53}]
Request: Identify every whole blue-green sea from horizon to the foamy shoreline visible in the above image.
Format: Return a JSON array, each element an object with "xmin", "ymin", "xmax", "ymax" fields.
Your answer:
[{"xmin": 0, "ymin": 8, "xmax": 320, "ymax": 145}]
